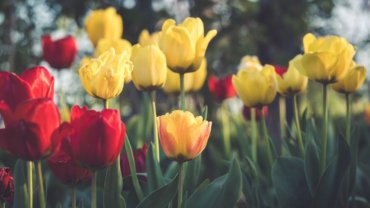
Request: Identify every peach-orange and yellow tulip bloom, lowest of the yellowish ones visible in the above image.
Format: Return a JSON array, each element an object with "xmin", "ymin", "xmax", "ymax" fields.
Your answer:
[{"xmin": 158, "ymin": 110, "xmax": 212, "ymax": 162}]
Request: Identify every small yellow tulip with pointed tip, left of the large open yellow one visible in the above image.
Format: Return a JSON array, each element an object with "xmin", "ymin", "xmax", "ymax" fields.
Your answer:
[{"xmin": 276, "ymin": 55, "xmax": 308, "ymax": 96}]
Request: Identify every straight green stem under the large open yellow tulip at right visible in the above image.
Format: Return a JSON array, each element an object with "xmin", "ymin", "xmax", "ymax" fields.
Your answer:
[{"xmin": 320, "ymin": 84, "xmax": 328, "ymax": 175}]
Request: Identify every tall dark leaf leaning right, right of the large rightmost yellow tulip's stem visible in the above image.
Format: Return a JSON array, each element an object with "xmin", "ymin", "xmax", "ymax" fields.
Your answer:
[{"xmin": 313, "ymin": 138, "xmax": 351, "ymax": 208}]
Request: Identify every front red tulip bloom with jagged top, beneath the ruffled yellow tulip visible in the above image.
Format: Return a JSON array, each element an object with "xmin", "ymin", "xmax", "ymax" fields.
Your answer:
[{"xmin": 69, "ymin": 106, "xmax": 126, "ymax": 169}]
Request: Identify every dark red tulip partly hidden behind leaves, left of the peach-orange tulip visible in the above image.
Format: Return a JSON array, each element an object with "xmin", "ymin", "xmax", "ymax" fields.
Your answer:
[{"xmin": 121, "ymin": 144, "xmax": 148, "ymax": 177}]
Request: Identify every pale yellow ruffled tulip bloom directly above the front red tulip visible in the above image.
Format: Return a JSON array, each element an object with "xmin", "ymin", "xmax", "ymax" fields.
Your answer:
[{"xmin": 79, "ymin": 48, "xmax": 132, "ymax": 100}]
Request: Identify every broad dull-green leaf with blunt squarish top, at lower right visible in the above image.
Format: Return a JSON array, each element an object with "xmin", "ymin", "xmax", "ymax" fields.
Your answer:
[{"xmin": 271, "ymin": 157, "xmax": 312, "ymax": 208}]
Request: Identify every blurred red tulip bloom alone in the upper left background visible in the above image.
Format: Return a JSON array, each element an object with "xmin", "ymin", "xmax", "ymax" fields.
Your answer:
[{"xmin": 42, "ymin": 35, "xmax": 77, "ymax": 70}]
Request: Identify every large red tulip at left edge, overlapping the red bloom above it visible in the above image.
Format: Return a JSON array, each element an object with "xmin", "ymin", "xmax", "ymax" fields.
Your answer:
[{"xmin": 0, "ymin": 98, "xmax": 60, "ymax": 161}]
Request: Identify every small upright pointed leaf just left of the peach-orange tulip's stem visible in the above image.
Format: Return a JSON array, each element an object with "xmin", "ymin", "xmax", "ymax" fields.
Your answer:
[{"xmin": 146, "ymin": 143, "xmax": 164, "ymax": 192}]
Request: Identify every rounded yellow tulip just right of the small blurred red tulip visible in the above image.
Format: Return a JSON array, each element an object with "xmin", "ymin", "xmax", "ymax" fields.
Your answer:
[{"xmin": 232, "ymin": 65, "xmax": 277, "ymax": 108}]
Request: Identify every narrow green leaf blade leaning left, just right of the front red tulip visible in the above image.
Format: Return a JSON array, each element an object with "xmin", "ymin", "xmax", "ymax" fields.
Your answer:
[{"xmin": 125, "ymin": 135, "xmax": 144, "ymax": 201}]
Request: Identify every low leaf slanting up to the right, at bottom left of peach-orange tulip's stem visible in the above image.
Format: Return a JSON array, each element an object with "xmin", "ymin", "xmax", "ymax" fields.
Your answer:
[{"xmin": 137, "ymin": 176, "xmax": 179, "ymax": 208}]
